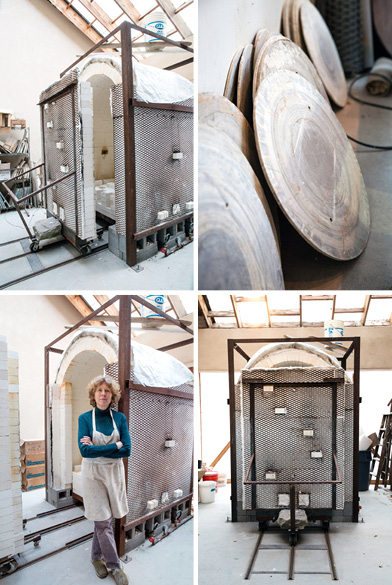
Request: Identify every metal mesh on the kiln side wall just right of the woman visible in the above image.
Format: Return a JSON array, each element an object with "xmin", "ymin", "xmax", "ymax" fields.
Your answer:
[{"xmin": 105, "ymin": 363, "xmax": 193, "ymax": 522}]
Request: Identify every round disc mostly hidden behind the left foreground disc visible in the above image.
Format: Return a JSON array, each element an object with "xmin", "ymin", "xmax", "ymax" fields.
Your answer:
[{"xmin": 198, "ymin": 93, "xmax": 261, "ymax": 175}]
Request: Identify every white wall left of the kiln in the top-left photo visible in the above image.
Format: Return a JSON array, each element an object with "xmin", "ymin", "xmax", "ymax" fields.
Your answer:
[{"xmin": 0, "ymin": 0, "xmax": 93, "ymax": 162}]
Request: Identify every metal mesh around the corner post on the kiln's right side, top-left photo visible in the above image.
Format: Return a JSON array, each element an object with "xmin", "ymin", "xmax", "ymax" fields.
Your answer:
[{"xmin": 112, "ymin": 85, "xmax": 193, "ymax": 235}]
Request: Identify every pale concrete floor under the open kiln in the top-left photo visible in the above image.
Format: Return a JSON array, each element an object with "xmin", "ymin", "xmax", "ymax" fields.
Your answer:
[{"xmin": 0, "ymin": 209, "xmax": 194, "ymax": 291}]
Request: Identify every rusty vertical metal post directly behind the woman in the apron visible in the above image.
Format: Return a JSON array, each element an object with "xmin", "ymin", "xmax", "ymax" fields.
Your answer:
[{"xmin": 114, "ymin": 295, "xmax": 131, "ymax": 557}]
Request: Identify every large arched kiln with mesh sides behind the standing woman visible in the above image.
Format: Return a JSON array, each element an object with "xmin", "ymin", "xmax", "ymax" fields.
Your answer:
[{"xmin": 47, "ymin": 328, "xmax": 193, "ymax": 549}]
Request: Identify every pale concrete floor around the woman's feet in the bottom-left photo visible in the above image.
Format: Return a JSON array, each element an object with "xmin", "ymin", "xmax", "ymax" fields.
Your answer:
[{"xmin": 2, "ymin": 489, "xmax": 194, "ymax": 585}]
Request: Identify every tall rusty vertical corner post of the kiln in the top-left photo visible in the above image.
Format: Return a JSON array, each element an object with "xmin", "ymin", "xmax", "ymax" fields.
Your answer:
[{"xmin": 121, "ymin": 21, "xmax": 136, "ymax": 266}]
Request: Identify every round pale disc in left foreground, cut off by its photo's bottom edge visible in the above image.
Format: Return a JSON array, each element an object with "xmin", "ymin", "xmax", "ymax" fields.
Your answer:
[{"xmin": 198, "ymin": 124, "xmax": 284, "ymax": 290}]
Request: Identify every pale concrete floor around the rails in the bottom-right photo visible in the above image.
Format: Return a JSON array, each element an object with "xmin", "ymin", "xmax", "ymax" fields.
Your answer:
[{"xmin": 198, "ymin": 486, "xmax": 392, "ymax": 585}]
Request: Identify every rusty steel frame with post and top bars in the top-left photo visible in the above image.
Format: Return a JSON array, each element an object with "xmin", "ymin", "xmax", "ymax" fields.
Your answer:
[{"xmin": 60, "ymin": 21, "xmax": 194, "ymax": 266}]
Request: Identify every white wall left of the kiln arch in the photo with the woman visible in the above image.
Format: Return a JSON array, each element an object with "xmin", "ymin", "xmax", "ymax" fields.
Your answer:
[{"xmin": 0, "ymin": 294, "xmax": 80, "ymax": 441}]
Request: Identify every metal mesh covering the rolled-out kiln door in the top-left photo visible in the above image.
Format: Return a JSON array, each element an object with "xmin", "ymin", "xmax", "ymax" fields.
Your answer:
[{"xmin": 40, "ymin": 72, "xmax": 84, "ymax": 238}]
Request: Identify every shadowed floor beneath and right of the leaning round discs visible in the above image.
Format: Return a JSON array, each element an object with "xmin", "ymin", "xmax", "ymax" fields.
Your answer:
[{"xmin": 280, "ymin": 79, "xmax": 392, "ymax": 290}]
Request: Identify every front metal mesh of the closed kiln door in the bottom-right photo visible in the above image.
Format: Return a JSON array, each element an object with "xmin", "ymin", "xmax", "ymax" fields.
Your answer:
[{"xmin": 235, "ymin": 367, "xmax": 353, "ymax": 510}]
